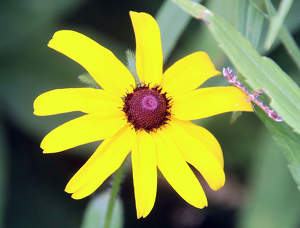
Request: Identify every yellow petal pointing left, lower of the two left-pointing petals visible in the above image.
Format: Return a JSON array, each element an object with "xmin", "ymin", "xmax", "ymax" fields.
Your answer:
[{"xmin": 41, "ymin": 111, "xmax": 127, "ymax": 153}]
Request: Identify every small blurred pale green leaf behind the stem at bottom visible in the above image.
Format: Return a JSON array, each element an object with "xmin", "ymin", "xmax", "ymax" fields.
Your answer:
[{"xmin": 81, "ymin": 191, "xmax": 123, "ymax": 228}]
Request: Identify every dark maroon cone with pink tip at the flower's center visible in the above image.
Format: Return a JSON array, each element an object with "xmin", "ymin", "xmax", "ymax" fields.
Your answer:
[{"xmin": 123, "ymin": 85, "xmax": 171, "ymax": 131}]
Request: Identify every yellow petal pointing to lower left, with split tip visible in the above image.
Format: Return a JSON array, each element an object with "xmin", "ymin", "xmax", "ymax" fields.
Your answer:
[{"xmin": 65, "ymin": 124, "xmax": 135, "ymax": 199}]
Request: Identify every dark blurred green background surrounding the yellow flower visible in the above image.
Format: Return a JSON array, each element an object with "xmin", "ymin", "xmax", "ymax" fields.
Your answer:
[{"xmin": 0, "ymin": 0, "xmax": 300, "ymax": 228}]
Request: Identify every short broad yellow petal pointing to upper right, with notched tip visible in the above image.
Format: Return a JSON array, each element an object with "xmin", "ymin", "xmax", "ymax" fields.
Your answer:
[{"xmin": 161, "ymin": 51, "xmax": 221, "ymax": 98}]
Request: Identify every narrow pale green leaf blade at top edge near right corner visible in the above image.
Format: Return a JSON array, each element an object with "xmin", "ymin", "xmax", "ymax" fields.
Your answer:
[{"xmin": 265, "ymin": 0, "xmax": 293, "ymax": 49}]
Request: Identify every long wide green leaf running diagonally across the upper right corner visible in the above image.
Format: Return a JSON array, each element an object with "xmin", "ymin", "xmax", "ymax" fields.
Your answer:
[{"xmin": 173, "ymin": 0, "xmax": 300, "ymax": 133}]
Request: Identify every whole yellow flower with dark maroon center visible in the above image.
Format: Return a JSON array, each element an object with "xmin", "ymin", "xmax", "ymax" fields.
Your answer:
[{"xmin": 34, "ymin": 12, "xmax": 253, "ymax": 218}]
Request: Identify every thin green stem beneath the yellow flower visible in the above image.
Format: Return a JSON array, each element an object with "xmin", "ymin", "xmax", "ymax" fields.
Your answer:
[{"xmin": 104, "ymin": 159, "xmax": 127, "ymax": 228}]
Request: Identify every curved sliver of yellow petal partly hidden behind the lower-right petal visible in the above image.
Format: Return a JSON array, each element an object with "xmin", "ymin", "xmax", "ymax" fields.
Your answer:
[{"xmin": 171, "ymin": 118, "xmax": 224, "ymax": 168}]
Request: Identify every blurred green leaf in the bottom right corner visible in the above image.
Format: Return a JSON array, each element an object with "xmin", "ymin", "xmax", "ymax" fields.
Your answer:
[{"xmin": 237, "ymin": 129, "xmax": 300, "ymax": 228}]
